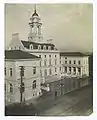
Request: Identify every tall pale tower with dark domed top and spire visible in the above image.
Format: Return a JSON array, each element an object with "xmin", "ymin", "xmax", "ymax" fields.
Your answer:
[{"xmin": 28, "ymin": 5, "xmax": 43, "ymax": 42}]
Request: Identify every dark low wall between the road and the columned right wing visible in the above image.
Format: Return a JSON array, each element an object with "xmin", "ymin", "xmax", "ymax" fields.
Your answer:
[{"xmin": 49, "ymin": 77, "xmax": 91, "ymax": 99}]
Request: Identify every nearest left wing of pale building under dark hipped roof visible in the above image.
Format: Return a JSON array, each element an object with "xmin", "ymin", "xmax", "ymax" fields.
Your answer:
[{"xmin": 5, "ymin": 50, "xmax": 41, "ymax": 105}]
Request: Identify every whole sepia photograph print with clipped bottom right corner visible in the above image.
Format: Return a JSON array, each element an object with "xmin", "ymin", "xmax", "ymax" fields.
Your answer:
[{"xmin": 4, "ymin": 3, "xmax": 93, "ymax": 116}]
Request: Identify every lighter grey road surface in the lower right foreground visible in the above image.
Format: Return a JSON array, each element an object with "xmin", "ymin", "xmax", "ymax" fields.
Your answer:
[{"xmin": 38, "ymin": 86, "xmax": 92, "ymax": 116}]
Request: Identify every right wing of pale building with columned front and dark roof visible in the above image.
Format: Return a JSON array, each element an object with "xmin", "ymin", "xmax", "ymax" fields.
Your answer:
[{"xmin": 60, "ymin": 52, "xmax": 89, "ymax": 77}]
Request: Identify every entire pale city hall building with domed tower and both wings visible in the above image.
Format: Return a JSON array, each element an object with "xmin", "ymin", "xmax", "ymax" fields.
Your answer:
[{"xmin": 5, "ymin": 5, "xmax": 89, "ymax": 103}]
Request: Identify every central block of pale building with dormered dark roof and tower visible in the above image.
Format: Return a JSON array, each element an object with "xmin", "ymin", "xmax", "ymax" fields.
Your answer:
[{"xmin": 8, "ymin": 6, "xmax": 60, "ymax": 83}]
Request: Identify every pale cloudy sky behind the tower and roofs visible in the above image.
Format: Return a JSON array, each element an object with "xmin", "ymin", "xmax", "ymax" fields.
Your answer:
[{"xmin": 5, "ymin": 3, "xmax": 93, "ymax": 52}]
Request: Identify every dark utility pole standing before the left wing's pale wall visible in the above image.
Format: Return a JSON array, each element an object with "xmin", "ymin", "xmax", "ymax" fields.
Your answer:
[{"xmin": 19, "ymin": 66, "xmax": 25, "ymax": 104}]
